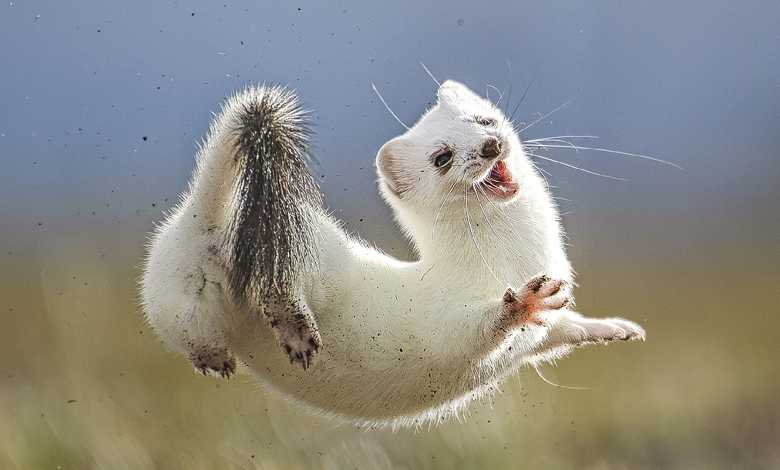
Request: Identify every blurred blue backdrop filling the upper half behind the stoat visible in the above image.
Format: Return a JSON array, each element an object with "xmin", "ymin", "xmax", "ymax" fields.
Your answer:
[{"xmin": 0, "ymin": 0, "xmax": 780, "ymax": 253}]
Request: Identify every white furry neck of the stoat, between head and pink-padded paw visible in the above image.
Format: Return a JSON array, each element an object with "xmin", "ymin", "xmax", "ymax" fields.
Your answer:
[{"xmin": 399, "ymin": 184, "xmax": 571, "ymax": 293}]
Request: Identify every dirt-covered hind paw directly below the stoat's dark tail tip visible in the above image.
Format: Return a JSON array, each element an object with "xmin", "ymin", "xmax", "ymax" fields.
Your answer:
[{"xmin": 262, "ymin": 294, "xmax": 322, "ymax": 370}]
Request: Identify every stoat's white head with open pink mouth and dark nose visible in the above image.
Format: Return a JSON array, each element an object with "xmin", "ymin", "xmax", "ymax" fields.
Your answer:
[{"xmin": 376, "ymin": 80, "xmax": 525, "ymax": 217}]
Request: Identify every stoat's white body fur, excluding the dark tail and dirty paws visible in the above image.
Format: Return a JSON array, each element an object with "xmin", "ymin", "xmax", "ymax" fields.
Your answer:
[{"xmin": 143, "ymin": 81, "xmax": 644, "ymax": 426}]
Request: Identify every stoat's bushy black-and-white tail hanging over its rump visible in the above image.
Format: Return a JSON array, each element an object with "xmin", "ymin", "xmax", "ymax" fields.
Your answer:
[{"xmin": 219, "ymin": 86, "xmax": 322, "ymax": 302}]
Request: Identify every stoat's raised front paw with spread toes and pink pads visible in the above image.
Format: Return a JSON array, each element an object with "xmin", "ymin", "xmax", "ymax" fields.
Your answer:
[{"xmin": 501, "ymin": 275, "xmax": 571, "ymax": 328}]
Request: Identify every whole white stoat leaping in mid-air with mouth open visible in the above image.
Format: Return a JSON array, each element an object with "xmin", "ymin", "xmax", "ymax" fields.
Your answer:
[{"xmin": 142, "ymin": 81, "xmax": 644, "ymax": 426}]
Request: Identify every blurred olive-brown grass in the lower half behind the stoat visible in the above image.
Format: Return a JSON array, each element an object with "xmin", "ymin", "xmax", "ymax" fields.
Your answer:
[{"xmin": 0, "ymin": 218, "xmax": 780, "ymax": 469}]
